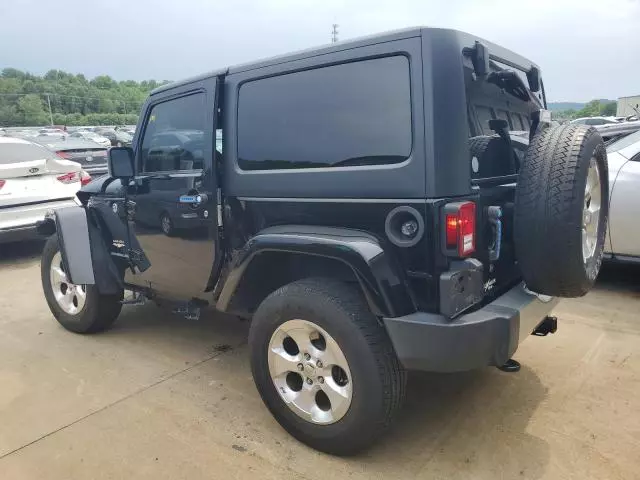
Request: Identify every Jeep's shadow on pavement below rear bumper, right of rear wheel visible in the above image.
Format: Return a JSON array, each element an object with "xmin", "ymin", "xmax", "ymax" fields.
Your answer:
[{"xmin": 350, "ymin": 366, "xmax": 550, "ymax": 480}]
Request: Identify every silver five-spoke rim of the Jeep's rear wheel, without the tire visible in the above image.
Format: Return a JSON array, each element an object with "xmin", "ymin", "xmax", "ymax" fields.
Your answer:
[{"xmin": 268, "ymin": 320, "xmax": 353, "ymax": 425}]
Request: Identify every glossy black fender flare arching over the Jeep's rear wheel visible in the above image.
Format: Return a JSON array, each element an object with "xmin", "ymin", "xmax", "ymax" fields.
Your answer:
[{"xmin": 216, "ymin": 225, "xmax": 416, "ymax": 317}]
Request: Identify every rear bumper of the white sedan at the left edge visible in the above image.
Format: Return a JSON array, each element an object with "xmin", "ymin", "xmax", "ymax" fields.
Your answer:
[{"xmin": 0, "ymin": 199, "xmax": 76, "ymax": 243}]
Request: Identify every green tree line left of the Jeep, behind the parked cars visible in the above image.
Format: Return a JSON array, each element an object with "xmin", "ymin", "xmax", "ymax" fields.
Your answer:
[{"xmin": 0, "ymin": 68, "xmax": 167, "ymax": 126}]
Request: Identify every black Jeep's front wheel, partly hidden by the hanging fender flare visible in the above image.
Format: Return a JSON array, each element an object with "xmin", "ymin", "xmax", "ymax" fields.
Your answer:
[{"xmin": 40, "ymin": 235, "xmax": 122, "ymax": 333}]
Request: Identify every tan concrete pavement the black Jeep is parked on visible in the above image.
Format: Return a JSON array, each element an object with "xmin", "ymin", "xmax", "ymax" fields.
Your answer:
[{"xmin": 0, "ymin": 246, "xmax": 640, "ymax": 480}]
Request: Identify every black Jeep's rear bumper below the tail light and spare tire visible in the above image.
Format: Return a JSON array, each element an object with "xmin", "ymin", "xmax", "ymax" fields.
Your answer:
[{"xmin": 384, "ymin": 284, "xmax": 558, "ymax": 372}]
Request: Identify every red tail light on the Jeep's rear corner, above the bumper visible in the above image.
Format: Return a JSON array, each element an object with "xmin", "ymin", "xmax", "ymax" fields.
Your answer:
[{"xmin": 444, "ymin": 202, "xmax": 476, "ymax": 257}]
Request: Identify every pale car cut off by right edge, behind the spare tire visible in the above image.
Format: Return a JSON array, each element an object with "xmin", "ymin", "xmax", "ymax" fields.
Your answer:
[{"xmin": 605, "ymin": 131, "xmax": 640, "ymax": 263}]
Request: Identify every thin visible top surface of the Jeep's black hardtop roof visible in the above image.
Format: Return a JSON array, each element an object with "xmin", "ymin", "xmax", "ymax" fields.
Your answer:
[{"xmin": 151, "ymin": 27, "xmax": 538, "ymax": 95}]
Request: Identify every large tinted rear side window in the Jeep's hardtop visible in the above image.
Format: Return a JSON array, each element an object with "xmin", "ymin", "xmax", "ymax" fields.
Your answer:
[{"xmin": 238, "ymin": 56, "xmax": 411, "ymax": 170}]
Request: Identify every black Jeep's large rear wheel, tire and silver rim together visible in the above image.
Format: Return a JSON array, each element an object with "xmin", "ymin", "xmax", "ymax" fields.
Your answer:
[{"xmin": 249, "ymin": 279, "xmax": 406, "ymax": 455}]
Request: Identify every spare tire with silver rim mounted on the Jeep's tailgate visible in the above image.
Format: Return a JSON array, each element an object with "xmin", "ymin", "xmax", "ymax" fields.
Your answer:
[{"xmin": 514, "ymin": 124, "xmax": 609, "ymax": 297}]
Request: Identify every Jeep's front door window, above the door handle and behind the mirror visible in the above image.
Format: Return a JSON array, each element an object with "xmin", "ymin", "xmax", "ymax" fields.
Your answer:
[{"xmin": 140, "ymin": 93, "xmax": 207, "ymax": 172}]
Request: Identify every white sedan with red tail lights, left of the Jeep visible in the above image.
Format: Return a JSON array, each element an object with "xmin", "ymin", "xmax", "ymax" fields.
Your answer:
[{"xmin": 0, "ymin": 137, "xmax": 91, "ymax": 243}]
